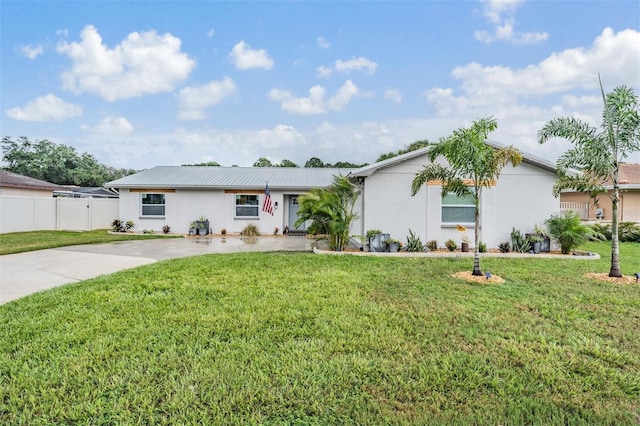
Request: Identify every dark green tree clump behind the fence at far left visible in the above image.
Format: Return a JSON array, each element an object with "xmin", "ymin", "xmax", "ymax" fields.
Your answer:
[{"xmin": 2, "ymin": 136, "xmax": 136, "ymax": 186}]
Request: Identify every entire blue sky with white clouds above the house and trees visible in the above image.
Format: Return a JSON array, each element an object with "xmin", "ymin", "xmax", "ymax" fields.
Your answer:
[{"xmin": 0, "ymin": 0, "xmax": 640, "ymax": 169}]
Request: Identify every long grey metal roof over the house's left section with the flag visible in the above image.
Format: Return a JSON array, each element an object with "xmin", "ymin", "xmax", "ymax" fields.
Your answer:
[{"xmin": 104, "ymin": 166, "xmax": 354, "ymax": 190}]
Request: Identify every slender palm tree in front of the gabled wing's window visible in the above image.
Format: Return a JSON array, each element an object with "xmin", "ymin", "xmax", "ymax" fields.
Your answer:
[{"xmin": 411, "ymin": 117, "xmax": 522, "ymax": 275}]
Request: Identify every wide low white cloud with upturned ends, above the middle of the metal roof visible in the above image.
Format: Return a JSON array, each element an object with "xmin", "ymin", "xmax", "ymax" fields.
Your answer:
[{"xmin": 269, "ymin": 80, "xmax": 358, "ymax": 115}]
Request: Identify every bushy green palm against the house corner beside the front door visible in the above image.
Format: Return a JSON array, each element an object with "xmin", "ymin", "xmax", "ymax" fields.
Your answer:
[{"xmin": 295, "ymin": 176, "xmax": 359, "ymax": 250}]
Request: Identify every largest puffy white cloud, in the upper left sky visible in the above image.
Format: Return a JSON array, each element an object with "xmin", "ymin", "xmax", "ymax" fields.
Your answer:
[{"xmin": 57, "ymin": 25, "xmax": 195, "ymax": 101}]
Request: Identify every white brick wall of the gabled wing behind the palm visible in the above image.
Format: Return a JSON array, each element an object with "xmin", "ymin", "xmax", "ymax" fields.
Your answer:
[{"xmin": 364, "ymin": 156, "xmax": 560, "ymax": 248}]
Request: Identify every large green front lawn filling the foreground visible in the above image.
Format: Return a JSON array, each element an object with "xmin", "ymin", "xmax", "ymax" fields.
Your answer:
[{"xmin": 0, "ymin": 243, "xmax": 640, "ymax": 425}]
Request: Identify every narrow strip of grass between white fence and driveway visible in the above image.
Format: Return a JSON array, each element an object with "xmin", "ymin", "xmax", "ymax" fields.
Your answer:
[{"xmin": 0, "ymin": 229, "xmax": 179, "ymax": 255}]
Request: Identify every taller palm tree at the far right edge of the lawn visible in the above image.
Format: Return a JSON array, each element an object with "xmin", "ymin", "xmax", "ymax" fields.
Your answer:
[{"xmin": 538, "ymin": 75, "xmax": 640, "ymax": 277}]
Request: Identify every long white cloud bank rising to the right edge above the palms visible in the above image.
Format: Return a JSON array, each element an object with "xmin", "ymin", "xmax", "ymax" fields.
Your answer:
[{"xmin": 426, "ymin": 28, "xmax": 640, "ymax": 114}]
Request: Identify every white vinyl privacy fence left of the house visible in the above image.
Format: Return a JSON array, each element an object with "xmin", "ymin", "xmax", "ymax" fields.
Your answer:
[{"xmin": 0, "ymin": 195, "xmax": 118, "ymax": 234}]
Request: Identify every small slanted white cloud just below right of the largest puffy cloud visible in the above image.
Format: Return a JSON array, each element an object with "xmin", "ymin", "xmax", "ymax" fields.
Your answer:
[{"xmin": 178, "ymin": 77, "xmax": 236, "ymax": 120}]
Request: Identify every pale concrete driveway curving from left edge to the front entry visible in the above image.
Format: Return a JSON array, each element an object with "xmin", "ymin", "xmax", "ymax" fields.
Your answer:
[{"xmin": 0, "ymin": 237, "xmax": 314, "ymax": 305}]
